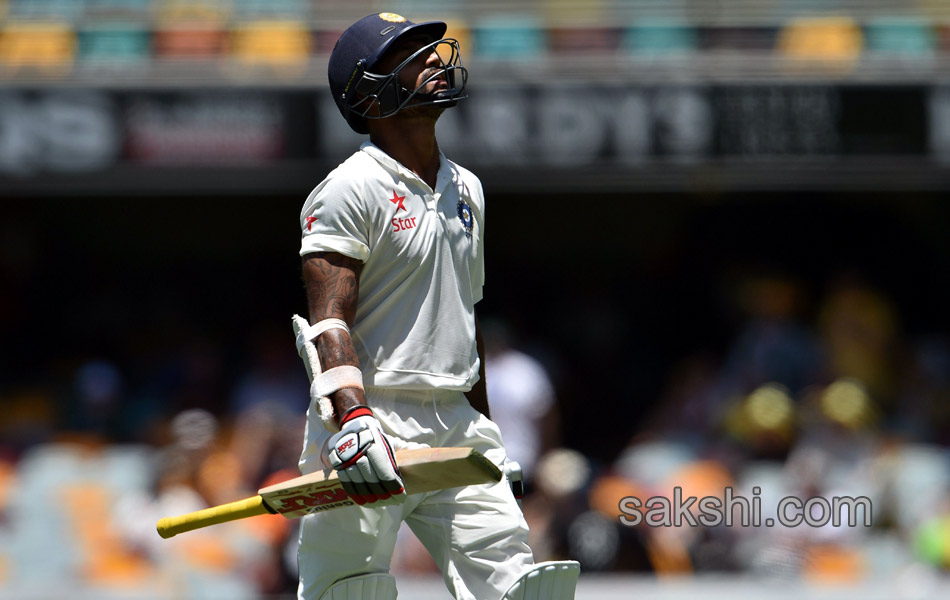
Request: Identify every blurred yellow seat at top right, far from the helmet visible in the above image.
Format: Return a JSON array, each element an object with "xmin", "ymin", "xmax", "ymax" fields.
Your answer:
[{"xmin": 777, "ymin": 17, "xmax": 864, "ymax": 65}]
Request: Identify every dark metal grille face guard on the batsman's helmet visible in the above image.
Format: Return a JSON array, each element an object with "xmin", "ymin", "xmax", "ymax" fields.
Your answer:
[{"xmin": 343, "ymin": 38, "xmax": 468, "ymax": 129}]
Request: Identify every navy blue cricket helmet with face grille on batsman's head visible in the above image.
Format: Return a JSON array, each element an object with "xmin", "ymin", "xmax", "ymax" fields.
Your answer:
[{"xmin": 327, "ymin": 12, "xmax": 468, "ymax": 134}]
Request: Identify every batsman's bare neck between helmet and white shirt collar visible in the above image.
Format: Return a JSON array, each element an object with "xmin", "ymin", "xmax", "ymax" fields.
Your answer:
[{"xmin": 370, "ymin": 120, "xmax": 440, "ymax": 190}]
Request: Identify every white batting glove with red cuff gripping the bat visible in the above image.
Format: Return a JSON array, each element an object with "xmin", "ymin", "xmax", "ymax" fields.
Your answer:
[{"xmin": 328, "ymin": 407, "xmax": 406, "ymax": 506}]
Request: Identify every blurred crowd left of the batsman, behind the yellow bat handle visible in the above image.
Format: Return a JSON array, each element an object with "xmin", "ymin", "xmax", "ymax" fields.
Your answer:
[{"xmin": 0, "ymin": 318, "xmax": 309, "ymax": 598}]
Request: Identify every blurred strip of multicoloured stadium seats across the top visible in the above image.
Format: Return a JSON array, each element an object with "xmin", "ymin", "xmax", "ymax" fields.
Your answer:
[{"xmin": 0, "ymin": 0, "xmax": 950, "ymax": 76}]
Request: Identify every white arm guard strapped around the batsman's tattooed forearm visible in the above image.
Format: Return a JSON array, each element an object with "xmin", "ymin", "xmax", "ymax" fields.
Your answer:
[{"xmin": 293, "ymin": 315, "xmax": 363, "ymax": 432}]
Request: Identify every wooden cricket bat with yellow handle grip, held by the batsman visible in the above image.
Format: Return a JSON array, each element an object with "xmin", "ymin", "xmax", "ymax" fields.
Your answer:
[{"xmin": 157, "ymin": 448, "xmax": 502, "ymax": 539}]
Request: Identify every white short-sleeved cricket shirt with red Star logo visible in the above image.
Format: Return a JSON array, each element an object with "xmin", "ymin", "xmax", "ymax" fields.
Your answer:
[{"xmin": 300, "ymin": 142, "xmax": 485, "ymax": 391}]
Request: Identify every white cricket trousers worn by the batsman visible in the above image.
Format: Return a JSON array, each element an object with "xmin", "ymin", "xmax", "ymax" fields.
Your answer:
[{"xmin": 297, "ymin": 388, "xmax": 534, "ymax": 600}]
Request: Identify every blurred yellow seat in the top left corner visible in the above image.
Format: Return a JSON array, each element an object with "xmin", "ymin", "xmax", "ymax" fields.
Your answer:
[{"xmin": 0, "ymin": 23, "xmax": 76, "ymax": 74}]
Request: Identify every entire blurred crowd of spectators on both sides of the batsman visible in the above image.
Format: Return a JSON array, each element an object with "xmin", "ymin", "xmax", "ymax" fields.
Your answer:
[{"xmin": 0, "ymin": 258, "xmax": 950, "ymax": 598}]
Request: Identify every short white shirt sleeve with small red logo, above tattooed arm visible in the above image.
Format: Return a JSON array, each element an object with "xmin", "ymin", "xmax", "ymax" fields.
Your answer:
[{"xmin": 300, "ymin": 169, "xmax": 370, "ymax": 262}]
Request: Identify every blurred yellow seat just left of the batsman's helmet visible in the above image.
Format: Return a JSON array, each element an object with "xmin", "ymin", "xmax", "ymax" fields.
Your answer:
[{"xmin": 231, "ymin": 21, "xmax": 313, "ymax": 66}]
